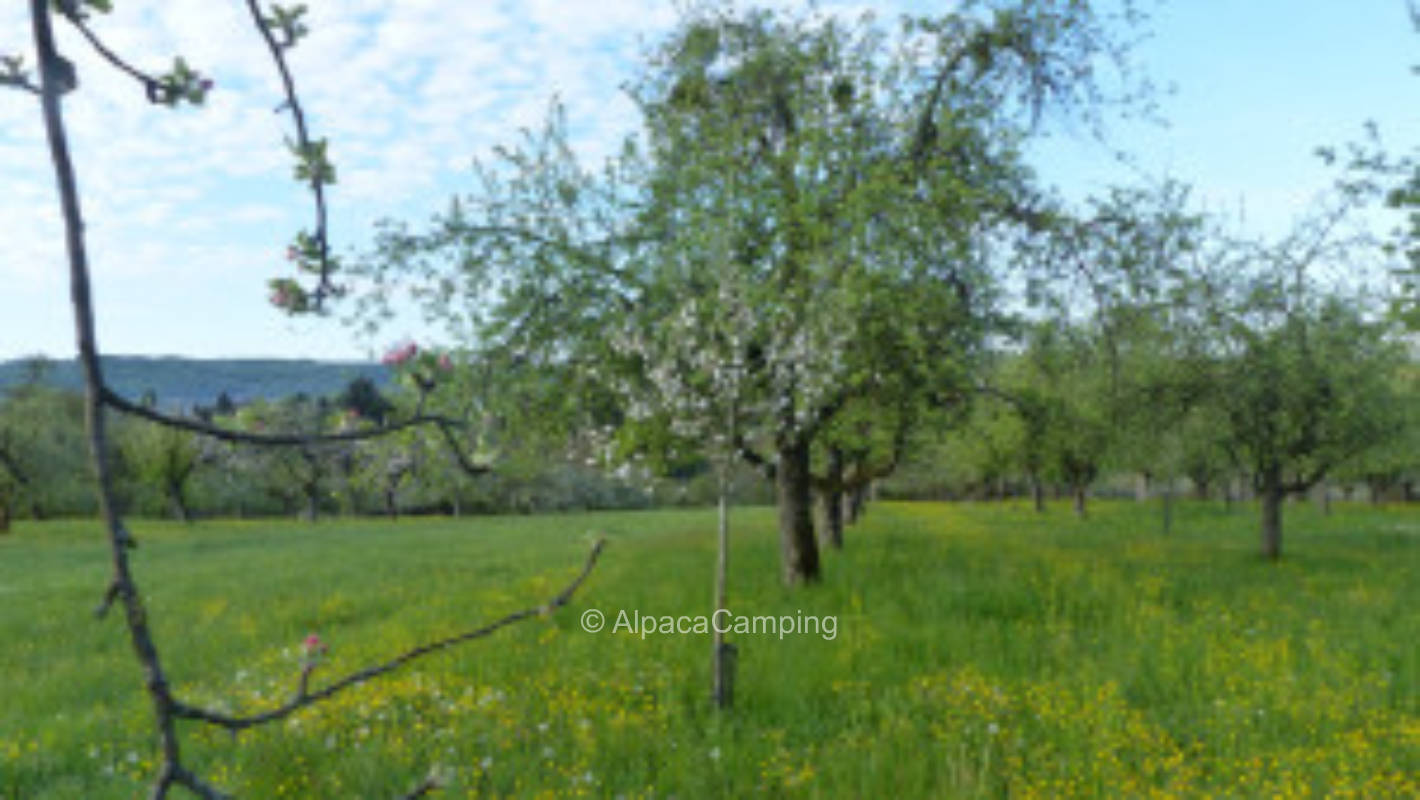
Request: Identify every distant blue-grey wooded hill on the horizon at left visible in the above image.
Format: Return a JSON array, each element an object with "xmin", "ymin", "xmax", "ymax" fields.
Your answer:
[{"xmin": 0, "ymin": 355, "xmax": 391, "ymax": 409}]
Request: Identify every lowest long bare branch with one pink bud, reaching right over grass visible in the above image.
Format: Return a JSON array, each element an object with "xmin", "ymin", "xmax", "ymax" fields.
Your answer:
[{"xmin": 172, "ymin": 539, "xmax": 606, "ymax": 730}]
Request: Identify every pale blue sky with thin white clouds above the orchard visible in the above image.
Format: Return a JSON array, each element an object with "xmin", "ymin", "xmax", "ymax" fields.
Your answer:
[{"xmin": 0, "ymin": 0, "xmax": 1420, "ymax": 360}]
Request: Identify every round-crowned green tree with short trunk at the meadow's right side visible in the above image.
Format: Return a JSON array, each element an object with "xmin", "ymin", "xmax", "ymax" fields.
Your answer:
[{"xmin": 1201, "ymin": 198, "xmax": 1403, "ymax": 560}]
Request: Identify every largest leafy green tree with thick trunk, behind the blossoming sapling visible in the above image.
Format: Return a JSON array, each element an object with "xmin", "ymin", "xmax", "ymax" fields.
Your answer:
[{"xmin": 365, "ymin": 0, "xmax": 1147, "ymax": 583}]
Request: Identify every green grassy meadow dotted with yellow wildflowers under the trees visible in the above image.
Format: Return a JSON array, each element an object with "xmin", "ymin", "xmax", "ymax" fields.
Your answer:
[{"xmin": 0, "ymin": 503, "xmax": 1420, "ymax": 799}]
